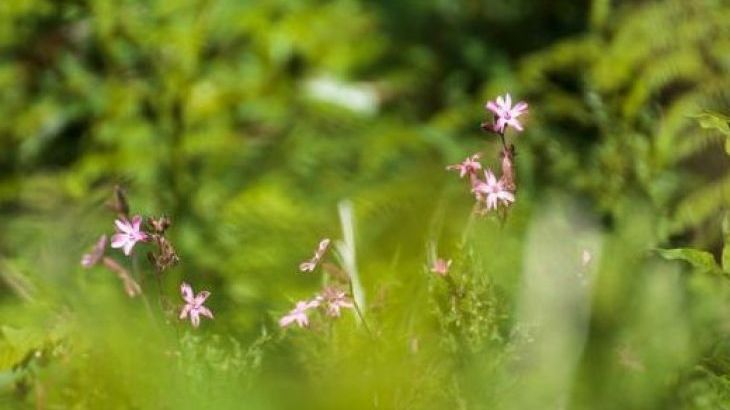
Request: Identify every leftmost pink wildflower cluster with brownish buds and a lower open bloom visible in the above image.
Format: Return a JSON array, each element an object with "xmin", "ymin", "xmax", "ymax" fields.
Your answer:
[{"xmin": 81, "ymin": 187, "xmax": 213, "ymax": 327}]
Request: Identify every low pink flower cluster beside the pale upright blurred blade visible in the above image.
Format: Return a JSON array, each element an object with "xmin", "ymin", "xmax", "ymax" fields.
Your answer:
[{"xmin": 279, "ymin": 239, "xmax": 355, "ymax": 328}]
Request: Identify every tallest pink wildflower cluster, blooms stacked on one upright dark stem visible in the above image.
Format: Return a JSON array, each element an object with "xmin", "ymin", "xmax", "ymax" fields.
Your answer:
[{"xmin": 446, "ymin": 94, "xmax": 527, "ymax": 212}]
